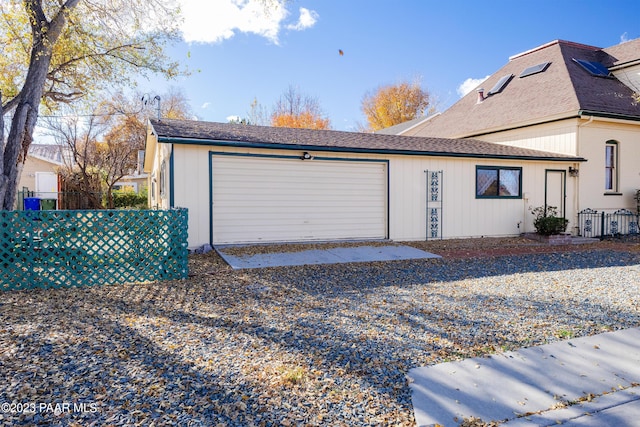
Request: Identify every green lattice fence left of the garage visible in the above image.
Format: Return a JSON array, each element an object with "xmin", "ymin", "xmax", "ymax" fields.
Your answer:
[{"xmin": 0, "ymin": 209, "xmax": 187, "ymax": 290}]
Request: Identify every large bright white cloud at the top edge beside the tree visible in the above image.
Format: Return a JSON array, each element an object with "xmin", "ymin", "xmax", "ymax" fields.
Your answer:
[{"xmin": 179, "ymin": 0, "xmax": 318, "ymax": 44}]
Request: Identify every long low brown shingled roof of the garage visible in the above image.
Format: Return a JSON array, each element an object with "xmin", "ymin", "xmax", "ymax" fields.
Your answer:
[{"xmin": 150, "ymin": 119, "xmax": 584, "ymax": 161}]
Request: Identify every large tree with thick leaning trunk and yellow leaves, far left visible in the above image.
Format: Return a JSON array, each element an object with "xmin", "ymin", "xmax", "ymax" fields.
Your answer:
[{"xmin": 0, "ymin": 0, "xmax": 185, "ymax": 210}]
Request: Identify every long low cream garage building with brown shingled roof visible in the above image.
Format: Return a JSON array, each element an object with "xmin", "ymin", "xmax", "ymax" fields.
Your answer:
[{"xmin": 144, "ymin": 119, "xmax": 583, "ymax": 247}]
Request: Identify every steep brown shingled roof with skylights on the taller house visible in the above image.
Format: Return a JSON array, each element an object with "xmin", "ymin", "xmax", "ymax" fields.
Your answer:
[{"xmin": 403, "ymin": 40, "xmax": 640, "ymax": 138}]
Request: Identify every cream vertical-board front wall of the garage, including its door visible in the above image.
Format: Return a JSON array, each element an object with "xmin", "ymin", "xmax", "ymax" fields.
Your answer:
[{"xmin": 169, "ymin": 144, "xmax": 577, "ymax": 248}]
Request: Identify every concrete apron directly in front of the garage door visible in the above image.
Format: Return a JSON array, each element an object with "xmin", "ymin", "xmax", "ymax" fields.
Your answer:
[{"xmin": 215, "ymin": 243, "xmax": 440, "ymax": 269}]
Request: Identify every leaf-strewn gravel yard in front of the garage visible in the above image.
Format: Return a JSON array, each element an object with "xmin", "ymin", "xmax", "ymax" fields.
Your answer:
[{"xmin": 0, "ymin": 239, "xmax": 640, "ymax": 426}]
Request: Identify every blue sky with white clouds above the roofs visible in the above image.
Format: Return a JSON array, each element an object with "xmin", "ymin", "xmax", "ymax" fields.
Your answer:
[{"xmin": 141, "ymin": 0, "xmax": 640, "ymax": 130}]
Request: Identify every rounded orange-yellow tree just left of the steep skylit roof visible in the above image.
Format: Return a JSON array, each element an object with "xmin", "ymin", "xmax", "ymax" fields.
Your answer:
[{"xmin": 362, "ymin": 81, "xmax": 431, "ymax": 131}]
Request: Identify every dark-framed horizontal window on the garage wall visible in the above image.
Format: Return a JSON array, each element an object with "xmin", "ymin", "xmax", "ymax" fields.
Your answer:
[{"xmin": 476, "ymin": 166, "xmax": 522, "ymax": 199}]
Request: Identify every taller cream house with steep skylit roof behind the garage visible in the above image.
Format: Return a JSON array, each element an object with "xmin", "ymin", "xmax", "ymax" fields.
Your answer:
[{"xmin": 398, "ymin": 39, "xmax": 640, "ymax": 234}]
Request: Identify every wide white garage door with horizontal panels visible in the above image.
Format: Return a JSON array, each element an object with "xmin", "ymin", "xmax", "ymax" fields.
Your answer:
[{"xmin": 211, "ymin": 154, "xmax": 387, "ymax": 244}]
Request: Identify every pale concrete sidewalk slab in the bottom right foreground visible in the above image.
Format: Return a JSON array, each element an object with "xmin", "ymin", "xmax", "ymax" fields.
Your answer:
[{"xmin": 408, "ymin": 328, "xmax": 640, "ymax": 427}]
